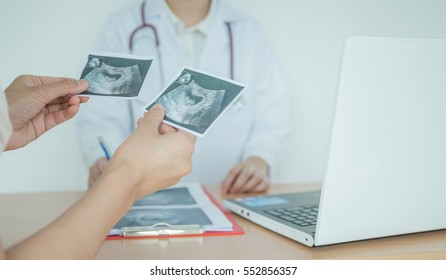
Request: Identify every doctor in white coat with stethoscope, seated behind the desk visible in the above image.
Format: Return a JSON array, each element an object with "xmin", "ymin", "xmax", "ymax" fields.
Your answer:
[{"xmin": 77, "ymin": 0, "xmax": 291, "ymax": 193}]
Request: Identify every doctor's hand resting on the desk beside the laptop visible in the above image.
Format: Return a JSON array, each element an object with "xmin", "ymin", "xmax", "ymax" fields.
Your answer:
[{"xmin": 221, "ymin": 156, "xmax": 269, "ymax": 194}]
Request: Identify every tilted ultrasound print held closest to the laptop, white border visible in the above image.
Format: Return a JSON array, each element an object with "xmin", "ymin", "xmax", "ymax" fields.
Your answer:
[{"xmin": 145, "ymin": 68, "xmax": 244, "ymax": 136}]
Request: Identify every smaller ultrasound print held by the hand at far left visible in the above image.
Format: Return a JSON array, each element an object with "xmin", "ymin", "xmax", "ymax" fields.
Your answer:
[{"xmin": 81, "ymin": 54, "xmax": 153, "ymax": 98}]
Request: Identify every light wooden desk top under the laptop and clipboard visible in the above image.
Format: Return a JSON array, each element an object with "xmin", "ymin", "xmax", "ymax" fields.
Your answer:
[{"xmin": 0, "ymin": 184, "xmax": 446, "ymax": 260}]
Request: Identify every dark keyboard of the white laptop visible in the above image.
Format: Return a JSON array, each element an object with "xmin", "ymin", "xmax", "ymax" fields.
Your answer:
[{"xmin": 263, "ymin": 205, "xmax": 319, "ymax": 227}]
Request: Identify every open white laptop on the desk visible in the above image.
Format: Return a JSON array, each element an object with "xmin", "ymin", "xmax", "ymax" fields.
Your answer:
[{"xmin": 224, "ymin": 37, "xmax": 446, "ymax": 246}]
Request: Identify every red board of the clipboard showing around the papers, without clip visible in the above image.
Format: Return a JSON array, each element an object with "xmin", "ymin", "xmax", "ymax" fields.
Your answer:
[{"xmin": 106, "ymin": 186, "xmax": 245, "ymax": 240}]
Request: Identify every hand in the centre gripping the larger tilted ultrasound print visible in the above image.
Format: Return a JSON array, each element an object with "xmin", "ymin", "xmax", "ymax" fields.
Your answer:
[{"xmin": 98, "ymin": 105, "xmax": 195, "ymax": 199}]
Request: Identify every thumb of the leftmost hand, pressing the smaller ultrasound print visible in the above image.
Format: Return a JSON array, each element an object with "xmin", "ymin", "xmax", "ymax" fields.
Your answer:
[{"xmin": 37, "ymin": 78, "xmax": 88, "ymax": 102}]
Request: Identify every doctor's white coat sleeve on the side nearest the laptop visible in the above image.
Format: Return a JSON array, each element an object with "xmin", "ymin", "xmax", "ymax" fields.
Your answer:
[{"xmin": 243, "ymin": 29, "xmax": 291, "ymax": 178}]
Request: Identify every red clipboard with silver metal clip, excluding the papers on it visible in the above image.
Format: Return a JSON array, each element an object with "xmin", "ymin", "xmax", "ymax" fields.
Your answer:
[{"xmin": 106, "ymin": 186, "xmax": 245, "ymax": 240}]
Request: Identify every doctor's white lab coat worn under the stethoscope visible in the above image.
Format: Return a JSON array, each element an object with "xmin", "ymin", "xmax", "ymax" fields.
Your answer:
[{"xmin": 77, "ymin": 0, "xmax": 291, "ymax": 185}]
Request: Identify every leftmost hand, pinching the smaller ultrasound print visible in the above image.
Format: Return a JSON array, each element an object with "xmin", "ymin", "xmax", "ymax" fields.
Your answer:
[{"xmin": 5, "ymin": 75, "xmax": 88, "ymax": 150}]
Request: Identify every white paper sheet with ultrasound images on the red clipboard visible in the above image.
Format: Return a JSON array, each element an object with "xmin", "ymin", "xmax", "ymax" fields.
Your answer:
[{"xmin": 109, "ymin": 183, "xmax": 232, "ymax": 235}]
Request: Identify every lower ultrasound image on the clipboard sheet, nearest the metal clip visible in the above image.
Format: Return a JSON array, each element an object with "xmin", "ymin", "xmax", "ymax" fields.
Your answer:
[{"xmin": 114, "ymin": 207, "xmax": 212, "ymax": 229}]
